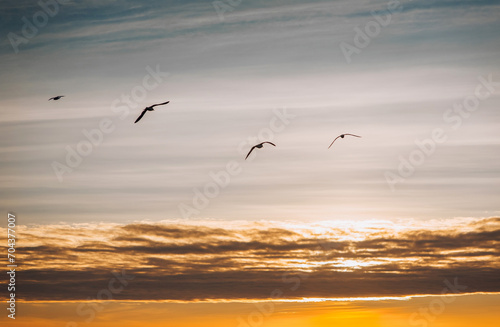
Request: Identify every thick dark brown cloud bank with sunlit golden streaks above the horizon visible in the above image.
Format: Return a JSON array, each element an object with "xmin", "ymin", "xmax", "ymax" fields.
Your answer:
[{"xmin": 1, "ymin": 218, "xmax": 500, "ymax": 301}]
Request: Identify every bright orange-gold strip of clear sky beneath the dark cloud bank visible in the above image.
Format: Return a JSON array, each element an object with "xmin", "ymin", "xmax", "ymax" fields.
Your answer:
[{"xmin": 0, "ymin": 294, "xmax": 500, "ymax": 327}]
